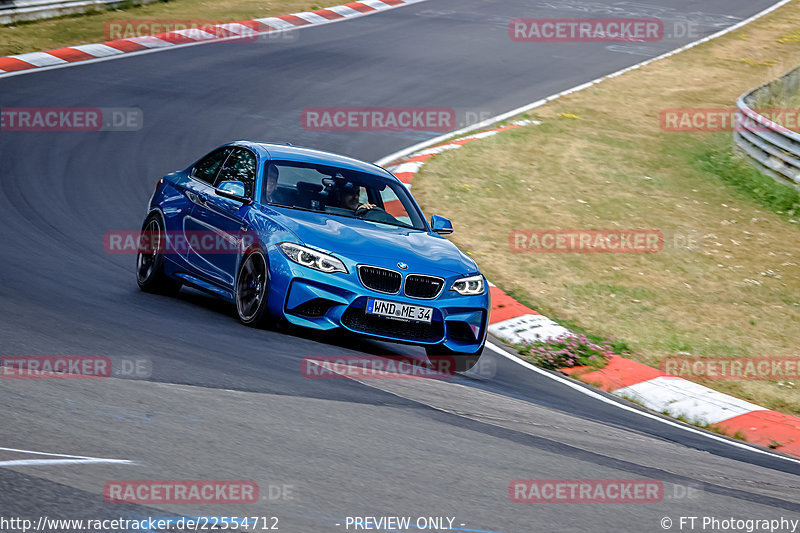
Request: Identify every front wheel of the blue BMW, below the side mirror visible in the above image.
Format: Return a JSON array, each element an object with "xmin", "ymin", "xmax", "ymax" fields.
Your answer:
[{"xmin": 235, "ymin": 250, "xmax": 269, "ymax": 328}]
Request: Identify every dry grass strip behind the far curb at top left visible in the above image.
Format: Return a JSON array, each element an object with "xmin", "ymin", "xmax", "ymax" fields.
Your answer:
[{"xmin": 0, "ymin": 0, "xmax": 341, "ymax": 56}]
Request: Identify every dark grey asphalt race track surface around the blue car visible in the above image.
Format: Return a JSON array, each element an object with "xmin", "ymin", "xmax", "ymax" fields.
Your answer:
[{"xmin": 0, "ymin": 0, "xmax": 800, "ymax": 533}]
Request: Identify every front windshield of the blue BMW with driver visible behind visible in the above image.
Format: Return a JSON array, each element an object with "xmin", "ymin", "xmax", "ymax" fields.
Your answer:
[{"xmin": 261, "ymin": 161, "xmax": 425, "ymax": 230}]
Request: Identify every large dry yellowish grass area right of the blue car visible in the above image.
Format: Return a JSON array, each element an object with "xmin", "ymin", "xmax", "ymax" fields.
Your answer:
[{"xmin": 414, "ymin": 2, "xmax": 800, "ymax": 415}]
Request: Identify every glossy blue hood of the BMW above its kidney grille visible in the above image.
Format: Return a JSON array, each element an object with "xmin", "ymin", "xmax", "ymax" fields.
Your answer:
[{"xmin": 270, "ymin": 206, "xmax": 478, "ymax": 275}]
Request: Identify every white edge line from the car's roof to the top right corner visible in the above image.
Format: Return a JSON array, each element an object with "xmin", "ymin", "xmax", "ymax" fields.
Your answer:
[{"xmin": 375, "ymin": 0, "xmax": 792, "ymax": 167}]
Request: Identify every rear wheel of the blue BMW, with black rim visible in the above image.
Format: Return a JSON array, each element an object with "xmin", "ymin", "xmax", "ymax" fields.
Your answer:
[{"xmin": 136, "ymin": 213, "xmax": 181, "ymax": 296}]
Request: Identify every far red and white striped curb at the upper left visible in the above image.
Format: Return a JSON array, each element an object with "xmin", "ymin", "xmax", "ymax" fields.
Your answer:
[{"xmin": 0, "ymin": 0, "xmax": 424, "ymax": 77}]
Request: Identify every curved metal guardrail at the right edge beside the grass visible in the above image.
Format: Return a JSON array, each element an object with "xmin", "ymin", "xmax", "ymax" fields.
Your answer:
[{"xmin": 733, "ymin": 67, "xmax": 800, "ymax": 188}]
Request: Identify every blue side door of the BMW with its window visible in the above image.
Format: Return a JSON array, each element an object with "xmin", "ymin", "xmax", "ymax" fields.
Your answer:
[{"xmin": 187, "ymin": 147, "xmax": 257, "ymax": 289}]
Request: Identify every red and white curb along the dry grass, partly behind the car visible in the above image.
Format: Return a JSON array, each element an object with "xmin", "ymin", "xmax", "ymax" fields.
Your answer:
[{"xmin": 386, "ymin": 120, "xmax": 800, "ymax": 457}]
